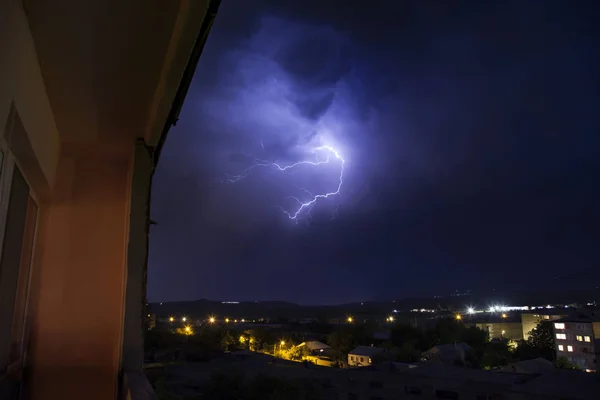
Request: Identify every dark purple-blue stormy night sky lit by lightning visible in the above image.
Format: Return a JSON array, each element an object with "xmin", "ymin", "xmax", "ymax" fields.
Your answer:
[{"xmin": 148, "ymin": 0, "xmax": 600, "ymax": 304}]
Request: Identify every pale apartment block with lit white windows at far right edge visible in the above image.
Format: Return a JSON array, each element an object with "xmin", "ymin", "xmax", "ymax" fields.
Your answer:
[{"xmin": 553, "ymin": 315, "xmax": 600, "ymax": 371}]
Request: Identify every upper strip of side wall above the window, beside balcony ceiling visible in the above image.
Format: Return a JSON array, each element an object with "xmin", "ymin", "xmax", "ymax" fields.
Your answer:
[{"xmin": 0, "ymin": 0, "xmax": 60, "ymax": 191}]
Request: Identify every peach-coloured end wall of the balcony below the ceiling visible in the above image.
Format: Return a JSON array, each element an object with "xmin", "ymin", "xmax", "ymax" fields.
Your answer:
[{"xmin": 29, "ymin": 150, "xmax": 134, "ymax": 400}]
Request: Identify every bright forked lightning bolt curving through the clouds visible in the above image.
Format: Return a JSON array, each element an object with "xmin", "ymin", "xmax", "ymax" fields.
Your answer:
[{"xmin": 227, "ymin": 146, "xmax": 346, "ymax": 220}]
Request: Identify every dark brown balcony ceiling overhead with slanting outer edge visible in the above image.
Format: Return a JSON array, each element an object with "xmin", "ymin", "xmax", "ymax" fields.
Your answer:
[{"xmin": 24, "ymin": 0, "xmax": 206, "ymax": 148}]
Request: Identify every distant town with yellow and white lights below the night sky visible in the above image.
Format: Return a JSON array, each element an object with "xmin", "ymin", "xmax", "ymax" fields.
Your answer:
[{"xmin": 145, "ymin": 291, "xmax": 600, "ymax": 400}]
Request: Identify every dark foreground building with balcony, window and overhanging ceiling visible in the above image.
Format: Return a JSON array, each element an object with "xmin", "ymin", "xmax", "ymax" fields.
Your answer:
[{"xmin": 0, "ymin": 0, "xmax": 219, "ymax": 400}]
